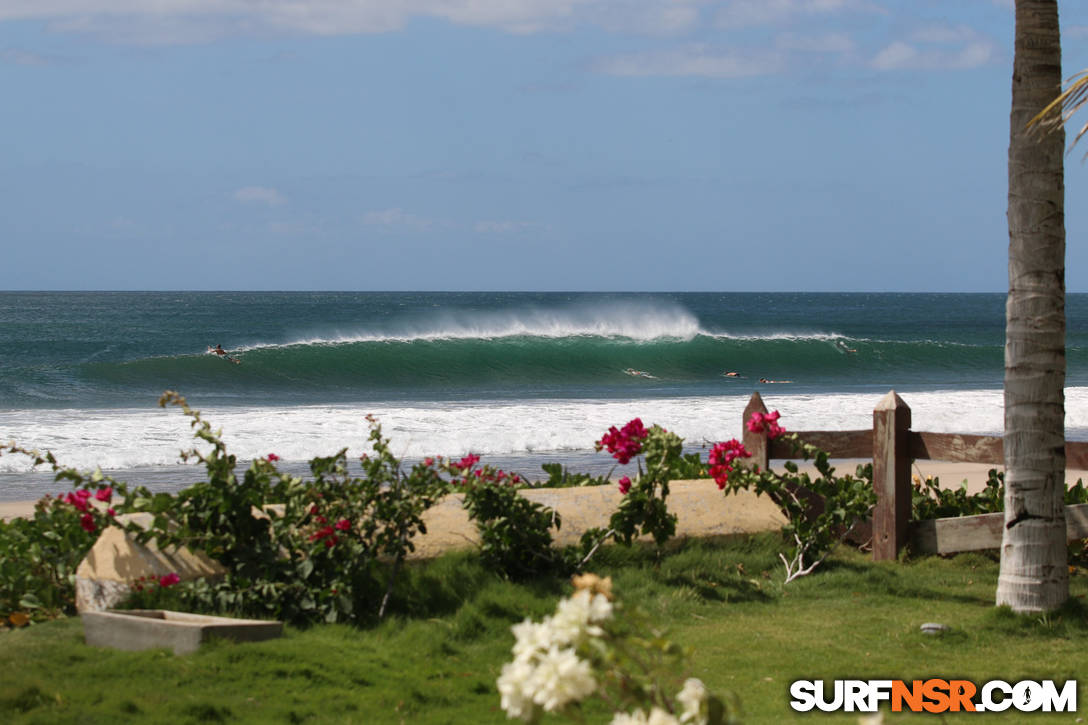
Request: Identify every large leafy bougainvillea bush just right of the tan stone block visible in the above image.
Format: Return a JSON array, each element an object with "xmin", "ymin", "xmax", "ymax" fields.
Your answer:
[{"xmin": 138, "ymin": 392, "xmax": 444, "ymax": 623}]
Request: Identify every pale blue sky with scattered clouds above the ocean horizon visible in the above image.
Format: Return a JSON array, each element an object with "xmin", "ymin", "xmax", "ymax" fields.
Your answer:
[{"xmin": 0, "ymin": 0, "xmax": 1088, "ymax": 292}]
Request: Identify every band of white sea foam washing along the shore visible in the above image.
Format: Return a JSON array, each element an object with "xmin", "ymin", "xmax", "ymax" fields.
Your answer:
[{"xmin": 8, "ymin": 388, "xmax": 1088, "ymax": 472}]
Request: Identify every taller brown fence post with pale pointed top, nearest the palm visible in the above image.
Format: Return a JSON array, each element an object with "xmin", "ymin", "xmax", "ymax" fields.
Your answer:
[{"xmin": 873, "ymin": 391, "xmax": 912, "ymax": 562}]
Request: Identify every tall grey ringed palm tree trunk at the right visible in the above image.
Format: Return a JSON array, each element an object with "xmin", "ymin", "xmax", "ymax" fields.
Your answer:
[{"xmin": 997, "ymin": 0, "xmax": 1068, "ymax": 612}]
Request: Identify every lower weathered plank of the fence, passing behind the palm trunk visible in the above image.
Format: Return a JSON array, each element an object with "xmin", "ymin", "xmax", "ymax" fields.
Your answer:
[{"xmin": 911, "ymin": 504, "xmax": 1088, "ymax": 554}]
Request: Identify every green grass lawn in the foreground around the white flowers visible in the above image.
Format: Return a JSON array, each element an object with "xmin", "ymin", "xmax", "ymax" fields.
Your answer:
[{"xmin": 0, "ymin": 536, "xmax": 1088, "ymax": 723}]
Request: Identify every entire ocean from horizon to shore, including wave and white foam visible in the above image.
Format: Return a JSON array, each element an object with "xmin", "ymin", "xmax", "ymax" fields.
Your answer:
[{"xmin": 0, "ymin": 292, "xmax": 1088, "ymax": 495}]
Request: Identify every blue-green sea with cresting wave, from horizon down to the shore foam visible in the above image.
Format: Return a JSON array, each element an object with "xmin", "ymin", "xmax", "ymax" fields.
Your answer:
[{"xmin": 6, "ymin": 293, "xmax": 1088, "ymax": 408}]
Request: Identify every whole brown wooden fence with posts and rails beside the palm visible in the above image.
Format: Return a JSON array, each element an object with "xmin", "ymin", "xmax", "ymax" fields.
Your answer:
[{"xmin": 741, "ymin": 391, "xmax": 1088, "ymax": 561}]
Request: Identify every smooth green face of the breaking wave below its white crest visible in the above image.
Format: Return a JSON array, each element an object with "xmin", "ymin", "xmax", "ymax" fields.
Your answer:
[{"xmin": 46, "ymin": 334, "xmax": 1002, "ymax": 400}]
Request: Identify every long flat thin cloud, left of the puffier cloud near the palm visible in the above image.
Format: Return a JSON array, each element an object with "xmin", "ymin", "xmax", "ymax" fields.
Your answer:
[{"xmin": 596, "ymin": 45, "xmax": 786, "ymax": 78}]
